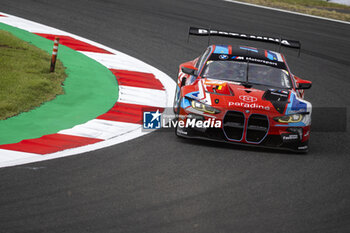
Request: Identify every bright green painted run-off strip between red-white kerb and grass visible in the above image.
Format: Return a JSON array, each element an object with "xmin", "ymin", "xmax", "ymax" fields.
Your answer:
[{"xmin": 0, "ymin": 23, "xmax": 118, "ymax": 144}]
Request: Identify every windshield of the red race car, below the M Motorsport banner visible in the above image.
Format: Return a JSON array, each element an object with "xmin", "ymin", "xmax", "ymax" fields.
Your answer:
[{"xmin": 202, "ymin": 61, "xmax": 292, "ymax": 88}]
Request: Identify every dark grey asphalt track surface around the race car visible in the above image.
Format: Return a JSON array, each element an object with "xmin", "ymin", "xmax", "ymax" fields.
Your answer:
[{"xmin": 0, "ymin": 0, "xmax": 350, "ymax": 233}]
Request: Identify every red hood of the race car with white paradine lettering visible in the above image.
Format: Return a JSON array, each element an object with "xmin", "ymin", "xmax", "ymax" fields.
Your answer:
[{"xmin": 189, "ymin": 78, "xmax": 311, "ymax": 115}]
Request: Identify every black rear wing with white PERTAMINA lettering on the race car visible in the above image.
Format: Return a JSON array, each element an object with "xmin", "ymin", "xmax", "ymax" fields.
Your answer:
[{"xmin": 188, "ymin": 27, "xmax": 301, "ymax": 52}]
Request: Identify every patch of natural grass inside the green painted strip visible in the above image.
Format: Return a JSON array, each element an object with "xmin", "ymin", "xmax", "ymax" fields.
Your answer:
[{"xmin": 0, "ymin": 30, "xmax": 67, "ymax": 120}]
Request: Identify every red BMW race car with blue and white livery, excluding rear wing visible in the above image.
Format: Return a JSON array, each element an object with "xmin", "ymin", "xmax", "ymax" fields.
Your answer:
[{"xmin": 174, "ymin": 28, "xmax": 312, "ymax": 152}]
